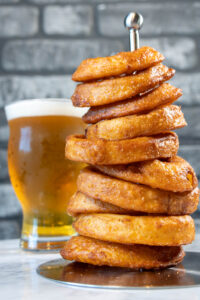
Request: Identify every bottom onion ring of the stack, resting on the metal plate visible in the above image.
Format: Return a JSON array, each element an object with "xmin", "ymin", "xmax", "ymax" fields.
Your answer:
[{"xmin": 60, "ymin": 236, "xmax": 185, "ymax": 269}]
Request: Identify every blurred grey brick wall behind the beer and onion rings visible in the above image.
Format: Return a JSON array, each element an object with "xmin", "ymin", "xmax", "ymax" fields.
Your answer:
[{"xmin": 0, "ymin": 0, "xmax": 200, "ymax": 238}]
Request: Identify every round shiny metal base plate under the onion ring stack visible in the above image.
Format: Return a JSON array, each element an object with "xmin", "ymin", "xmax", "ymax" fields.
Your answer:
[{"xmin": 37, "ymin": 252, "xmax": 200, "ymax": 289}]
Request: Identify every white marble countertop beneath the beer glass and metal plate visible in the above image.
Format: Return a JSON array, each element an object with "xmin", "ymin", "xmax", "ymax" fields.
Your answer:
[{"xmin": 0, "ymin": 234, "xmax": 200, "ymax": 300}]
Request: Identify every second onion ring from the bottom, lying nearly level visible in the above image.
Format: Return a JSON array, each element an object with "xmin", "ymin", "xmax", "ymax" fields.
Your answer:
[{"xmin": 73, "ymin": 214, "xmax": 195, "ymax": 246}]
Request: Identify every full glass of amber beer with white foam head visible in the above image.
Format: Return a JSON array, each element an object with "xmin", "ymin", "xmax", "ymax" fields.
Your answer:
[{"xmin": 5, "ymin": 99, "xmax": 85, "ymax": 250}]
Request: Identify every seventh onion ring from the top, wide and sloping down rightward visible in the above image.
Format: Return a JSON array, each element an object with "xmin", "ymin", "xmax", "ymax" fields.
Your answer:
[{"xmin": 77, "ymin": 167, "xmax": 199, "ymax": 215}]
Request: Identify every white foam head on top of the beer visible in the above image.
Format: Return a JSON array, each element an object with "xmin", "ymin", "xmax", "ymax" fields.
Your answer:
[{"xmin": 5, "ymin": 99, "xmax": 88, "ymax": 121}]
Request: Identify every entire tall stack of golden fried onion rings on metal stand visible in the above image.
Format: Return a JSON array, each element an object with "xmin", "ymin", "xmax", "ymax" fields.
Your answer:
[{"xmin": 61, "ymin": 47, "xmax": 199, "ymax": 269}]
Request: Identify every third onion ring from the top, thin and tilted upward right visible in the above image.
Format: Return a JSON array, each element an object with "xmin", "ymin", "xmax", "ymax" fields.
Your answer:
[{"xmin": 82, "ymin": 83, "xmax": 182, "ymax": 124}]
